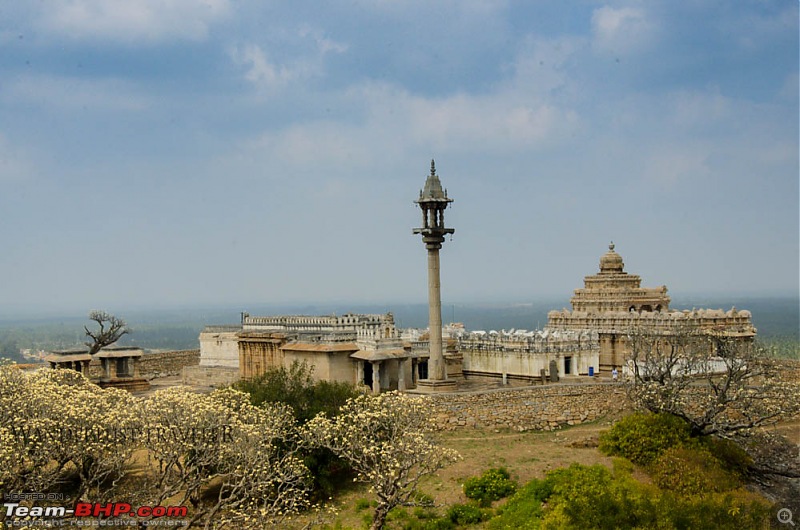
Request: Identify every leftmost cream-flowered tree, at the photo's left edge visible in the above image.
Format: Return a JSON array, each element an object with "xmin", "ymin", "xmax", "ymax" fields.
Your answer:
[{"xmin": 0, "ymin": 366, "xmax": 140, "ymax": 501}]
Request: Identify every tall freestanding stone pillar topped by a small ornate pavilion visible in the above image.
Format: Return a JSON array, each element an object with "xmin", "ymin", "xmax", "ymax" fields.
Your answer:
[{"xmin": 414, "ymin": 160, "xmax": 456, "ymax": 391}]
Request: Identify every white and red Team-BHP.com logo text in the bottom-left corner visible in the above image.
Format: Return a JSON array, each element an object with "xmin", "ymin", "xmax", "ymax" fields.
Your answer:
[{"xmin": 3, "ymin": 502, "xmax": 188, "ymax": 519}]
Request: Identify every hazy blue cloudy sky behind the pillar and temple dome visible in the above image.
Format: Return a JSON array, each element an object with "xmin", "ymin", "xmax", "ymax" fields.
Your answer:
[{"xmin": 0, "ymin": 0, "xmax": 800, "ymax": 314}]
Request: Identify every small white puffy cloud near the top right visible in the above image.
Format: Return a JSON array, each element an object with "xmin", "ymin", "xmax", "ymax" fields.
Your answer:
[{"xmin": 592, "ymin": 6, "xmax": 654, "ymax": 54}]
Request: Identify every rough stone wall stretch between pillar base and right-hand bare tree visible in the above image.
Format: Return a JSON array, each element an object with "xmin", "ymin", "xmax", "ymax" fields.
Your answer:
[{"xmin": 424, "ymin": 383, "xmax": 631, "ymax": 432}]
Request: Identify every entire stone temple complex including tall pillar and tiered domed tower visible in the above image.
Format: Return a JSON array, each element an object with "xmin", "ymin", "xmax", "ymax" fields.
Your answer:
[{"xmin": 188, "ymin": 161, "xmax": 756, "ymax": 393}]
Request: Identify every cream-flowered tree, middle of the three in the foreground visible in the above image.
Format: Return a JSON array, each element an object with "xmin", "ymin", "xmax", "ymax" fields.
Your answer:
[{"xmin": 143, "ymin": 387, "xmax": 309, "ymax": 526}]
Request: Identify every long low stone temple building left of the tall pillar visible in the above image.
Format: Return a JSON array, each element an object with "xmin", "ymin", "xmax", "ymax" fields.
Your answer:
[{"xmin": 193, "ymin": 313, "xmax": 428, "ymax": 393}]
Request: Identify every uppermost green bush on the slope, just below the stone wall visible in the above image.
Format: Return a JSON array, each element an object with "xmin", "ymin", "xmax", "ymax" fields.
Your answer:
[{"xmin": 600, "ymin": 413, "xmax": 690, "ymax": 465}]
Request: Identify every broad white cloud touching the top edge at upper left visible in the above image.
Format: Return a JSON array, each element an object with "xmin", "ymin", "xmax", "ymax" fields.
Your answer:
[{"xmin": 40, "ymin": 0, "xmax": 230, "ymax": 43}]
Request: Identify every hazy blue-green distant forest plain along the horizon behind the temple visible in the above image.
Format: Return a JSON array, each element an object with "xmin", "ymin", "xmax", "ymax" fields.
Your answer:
[{"xmin": 0, "ymin": 296, "xmax": 800, "ymax": 361}]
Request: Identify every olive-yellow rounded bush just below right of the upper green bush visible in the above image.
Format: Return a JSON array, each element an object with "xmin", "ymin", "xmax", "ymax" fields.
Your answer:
[{"xmin": 649, "ymin": 447, "xmax": 741, "ymax": 495}]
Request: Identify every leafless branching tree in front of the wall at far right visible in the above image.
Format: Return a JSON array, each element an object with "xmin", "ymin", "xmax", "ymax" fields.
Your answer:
[{"xmin": 627, "ymin": 327, "xmax": 800, "ymax": 438}]
